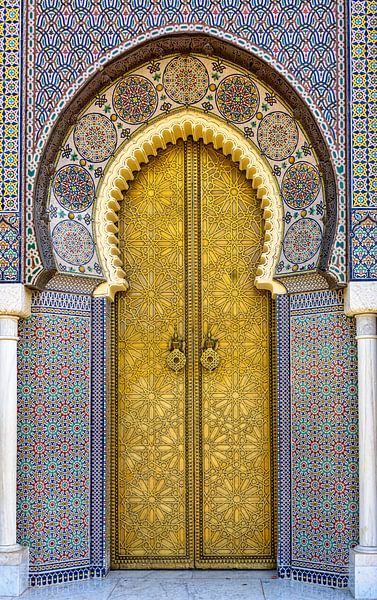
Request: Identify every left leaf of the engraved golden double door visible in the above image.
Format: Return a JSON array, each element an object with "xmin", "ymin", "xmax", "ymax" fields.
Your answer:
[{"xmin": 112, "ymin": 143, "xmax": 194, "ymax": 568}]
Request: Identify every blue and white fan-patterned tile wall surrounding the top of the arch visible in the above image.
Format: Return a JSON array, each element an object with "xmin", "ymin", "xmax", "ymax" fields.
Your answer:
[{"xmin": 25, "ymin": 0, "xmax": 346, "ymax": 288}]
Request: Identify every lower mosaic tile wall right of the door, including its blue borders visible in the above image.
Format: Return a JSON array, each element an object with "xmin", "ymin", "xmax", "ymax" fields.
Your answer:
[{"xmin": 278, "ymin": 291, "xmax": 358, "ymax": 587}]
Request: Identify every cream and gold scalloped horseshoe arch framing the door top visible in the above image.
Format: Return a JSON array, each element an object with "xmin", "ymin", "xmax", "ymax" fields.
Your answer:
[{"xmin": 94, "ymin": 109, "xmax": 285, "ymax": 300}]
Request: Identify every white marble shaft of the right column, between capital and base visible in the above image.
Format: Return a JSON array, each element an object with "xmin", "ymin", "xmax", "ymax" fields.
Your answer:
[{"xmin": 356, "ymin": 314, "xmax": 377, "ymax": 552}]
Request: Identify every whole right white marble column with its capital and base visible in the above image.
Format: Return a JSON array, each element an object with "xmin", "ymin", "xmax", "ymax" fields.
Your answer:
[{"xmin": 345, "ymin": 282, "xmax": 377, "ymax": 600}]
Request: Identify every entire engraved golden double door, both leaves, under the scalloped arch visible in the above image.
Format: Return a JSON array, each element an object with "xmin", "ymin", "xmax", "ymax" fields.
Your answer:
[{"xmin": 111, "ymin": 140, "xmax": 275, "ymax": 568}]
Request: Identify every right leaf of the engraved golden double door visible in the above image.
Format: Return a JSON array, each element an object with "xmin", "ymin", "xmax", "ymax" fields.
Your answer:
[{"xmin": 195, "ymin": 145, "xmax": 275, "ymax": 568}]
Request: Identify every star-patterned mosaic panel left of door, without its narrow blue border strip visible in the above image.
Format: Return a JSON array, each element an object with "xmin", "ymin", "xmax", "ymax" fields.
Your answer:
[{"xmin": 17, "ymin": 294, "xmax": 91, "ymax": 575}]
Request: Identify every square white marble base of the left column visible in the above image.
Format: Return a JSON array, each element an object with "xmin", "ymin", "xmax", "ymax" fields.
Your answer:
[{"xmin": 0, "ymin": 546, "xmax": 29, "ymax": 596}]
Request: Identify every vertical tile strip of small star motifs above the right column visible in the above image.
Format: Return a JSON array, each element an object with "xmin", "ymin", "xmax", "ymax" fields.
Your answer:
[{"xmin": 350, "ymin": 0, "xmax": 377, "ymax": 280}]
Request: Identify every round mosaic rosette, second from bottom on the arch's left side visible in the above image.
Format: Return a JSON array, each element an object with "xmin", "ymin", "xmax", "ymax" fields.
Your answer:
[{"xmin": 53, "ymin": 165, "xmax": 95, "ymax": 212}]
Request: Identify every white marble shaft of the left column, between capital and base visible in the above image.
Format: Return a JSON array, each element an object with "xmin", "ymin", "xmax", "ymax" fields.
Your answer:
[{"xmin": 0, "ymin": 315, "xmax": 18, "ymax": 550}]
